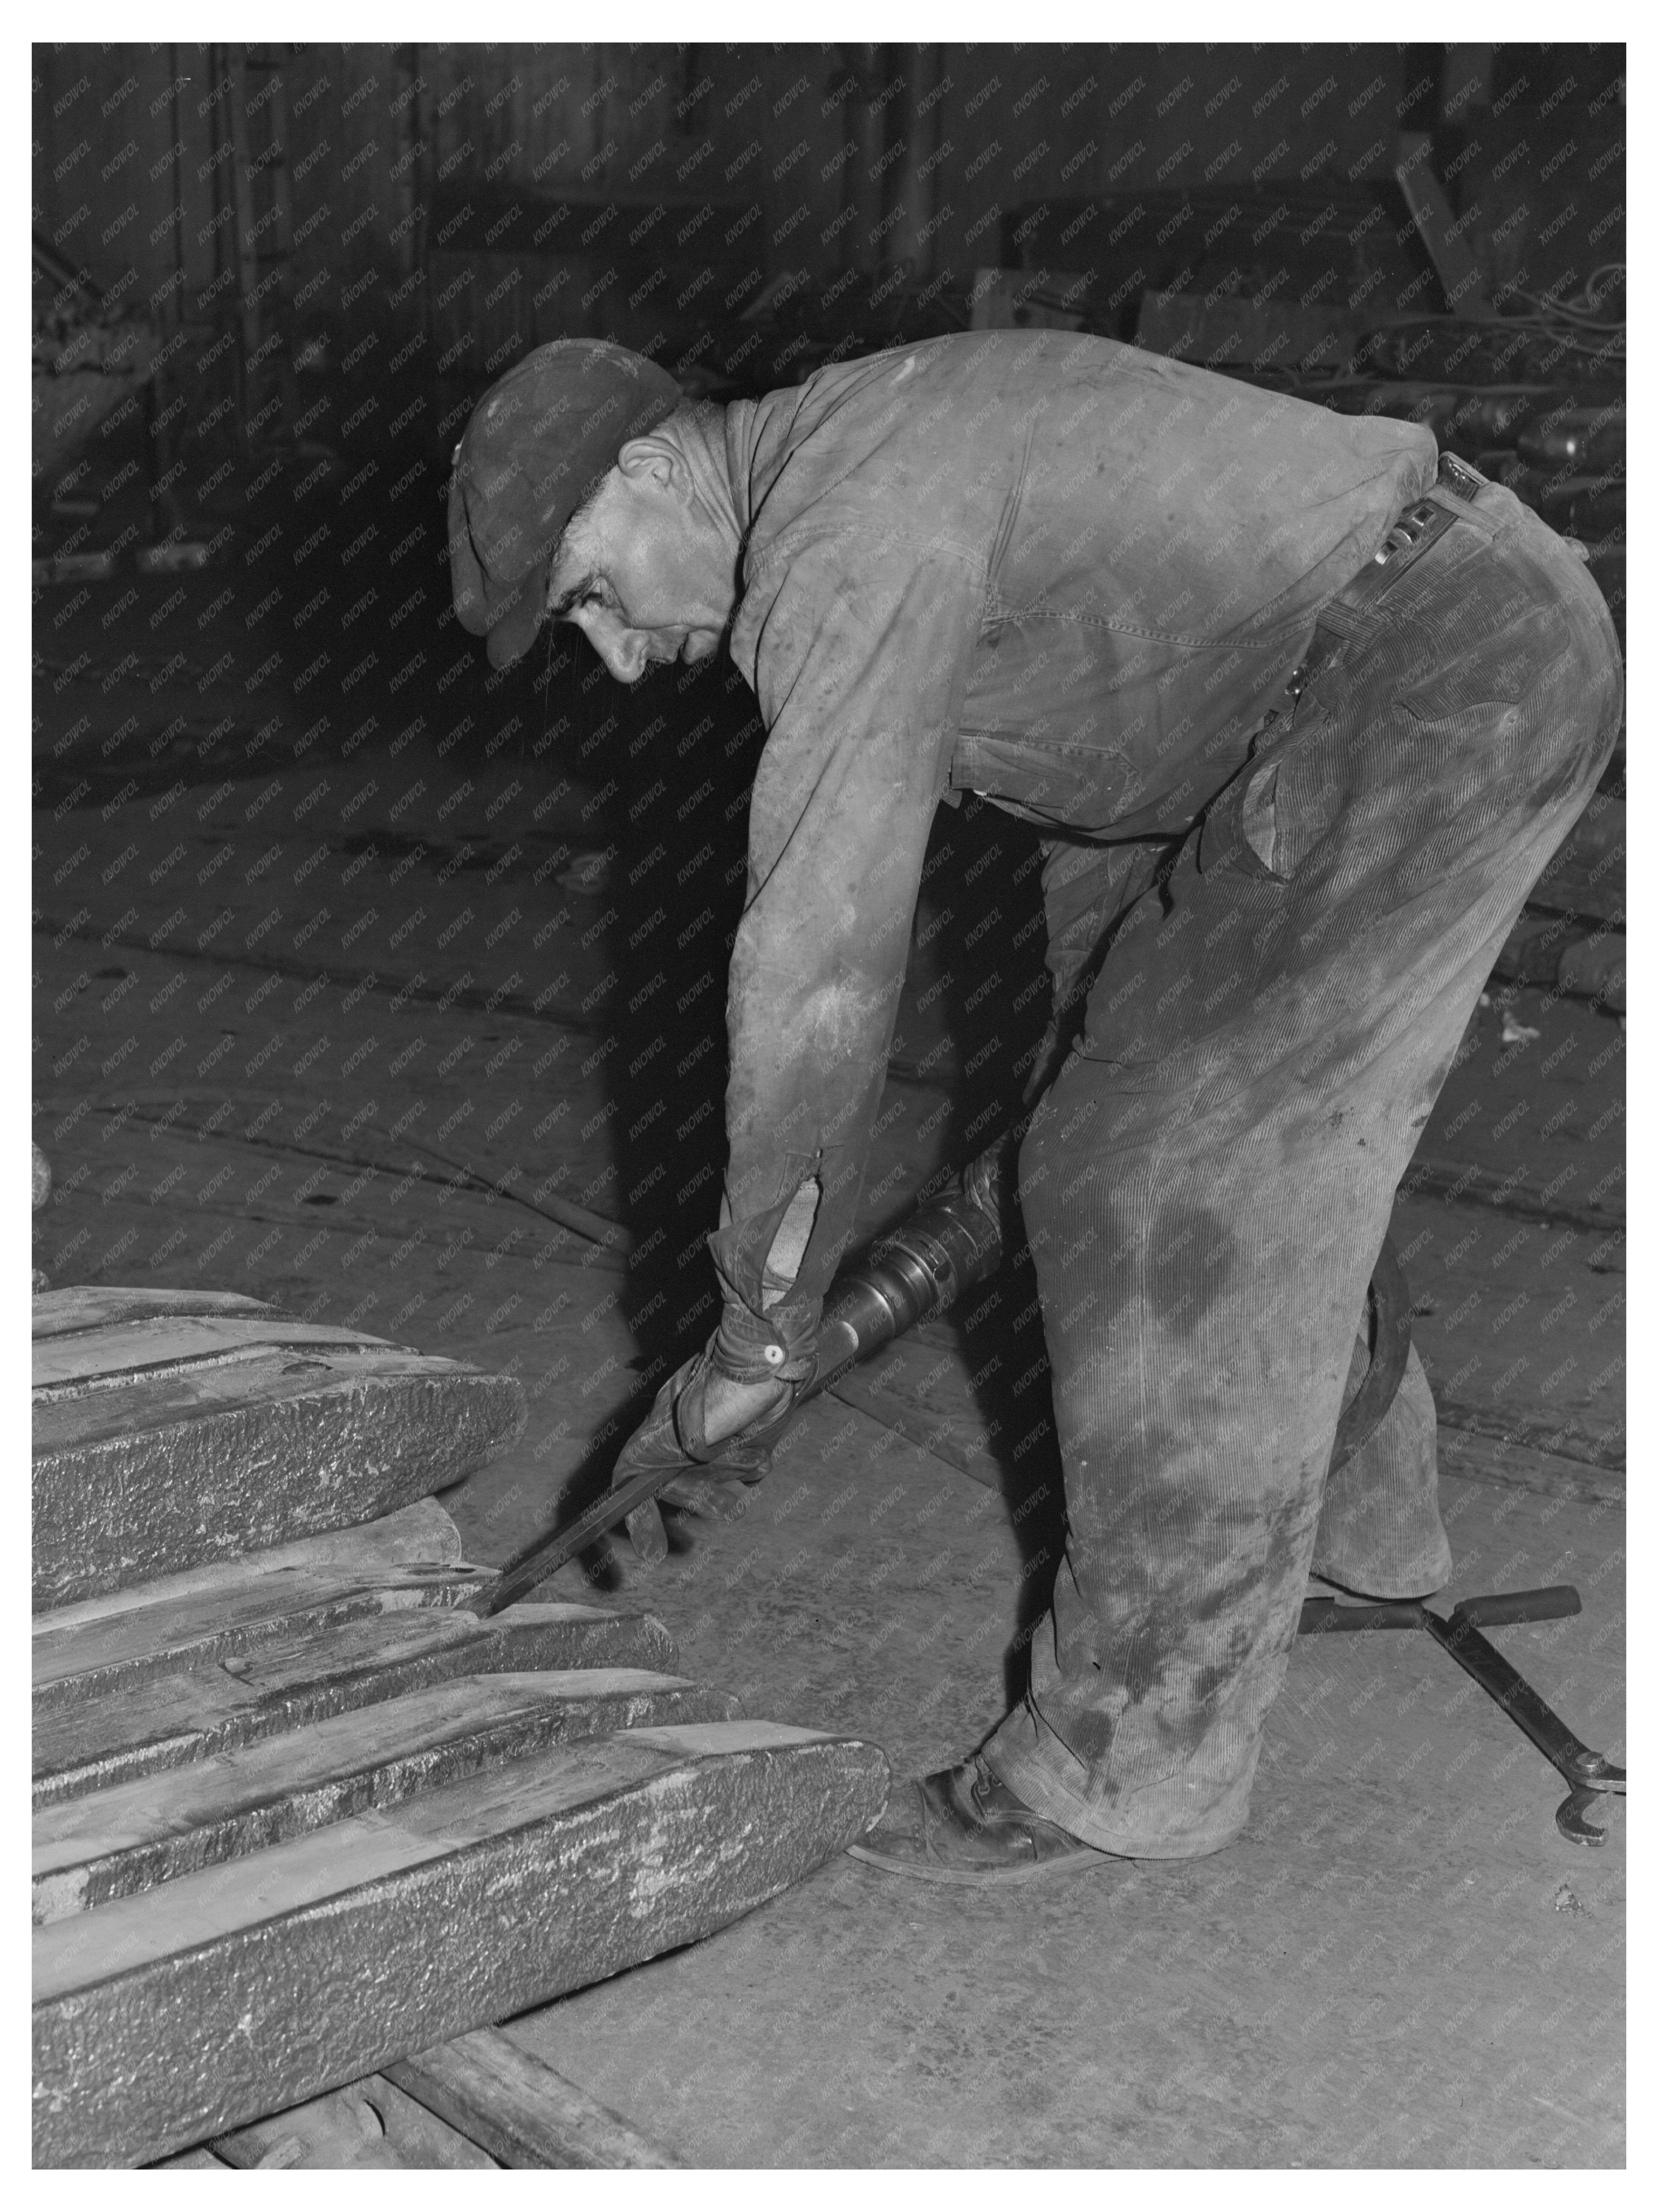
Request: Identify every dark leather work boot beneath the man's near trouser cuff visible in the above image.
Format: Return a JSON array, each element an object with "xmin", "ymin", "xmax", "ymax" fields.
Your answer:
[{"xmin": 851, "ymin": 1756, "xmax": 1114, "ymax": 1889}]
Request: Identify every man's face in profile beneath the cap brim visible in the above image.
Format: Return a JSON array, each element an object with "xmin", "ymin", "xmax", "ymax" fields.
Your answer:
[{"xmin": 546, "ymin": 449, "xmax": 736, "ymax": 683}]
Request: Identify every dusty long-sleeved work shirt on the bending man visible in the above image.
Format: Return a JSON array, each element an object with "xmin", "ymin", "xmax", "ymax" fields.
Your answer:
[{"xmin": 710, "ymin": 332, "xmax": 1437, "ymax": 1312}]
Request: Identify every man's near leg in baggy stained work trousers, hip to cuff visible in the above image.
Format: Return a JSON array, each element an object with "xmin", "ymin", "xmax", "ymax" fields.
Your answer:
[{"xmin": 984, "ymin": 493, "xmax": 1620, "ymax": 1856}]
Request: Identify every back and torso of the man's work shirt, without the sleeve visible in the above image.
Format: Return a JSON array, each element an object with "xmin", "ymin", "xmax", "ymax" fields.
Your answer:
[{"xmin": 725, "ymin": 332, "xmax": 1435, "ymax": 834}]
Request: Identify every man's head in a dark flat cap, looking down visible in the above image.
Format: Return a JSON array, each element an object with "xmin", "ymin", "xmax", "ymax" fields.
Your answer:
[{"xmin": 449, "ymin": 338, "xmax": 736, "ymax": 683}]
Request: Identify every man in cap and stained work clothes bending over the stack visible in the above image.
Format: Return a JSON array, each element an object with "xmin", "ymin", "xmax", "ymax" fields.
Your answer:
[{"xmin": 451, "ymin": 332, "xmax": 1623, "ymax": 1883}]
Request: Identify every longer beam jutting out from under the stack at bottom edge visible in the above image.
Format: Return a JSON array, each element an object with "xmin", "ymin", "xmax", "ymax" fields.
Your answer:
[{"xmin": 387, "ymin": 2028, "xmax": 681, "ymax": 2170}]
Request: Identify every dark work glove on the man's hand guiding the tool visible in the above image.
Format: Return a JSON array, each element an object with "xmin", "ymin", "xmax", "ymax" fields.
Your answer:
[{"xmin": 610, "ymin": 1298, "xmax": 818, "ymax": 1564}]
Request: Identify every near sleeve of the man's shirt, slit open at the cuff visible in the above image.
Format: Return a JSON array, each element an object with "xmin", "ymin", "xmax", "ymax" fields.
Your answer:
[{"xmin": 710, "ymin": 533, "xmax": 984, "ymax": 1314}]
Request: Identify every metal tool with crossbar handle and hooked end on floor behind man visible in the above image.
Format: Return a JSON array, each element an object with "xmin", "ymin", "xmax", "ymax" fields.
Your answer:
[{"xmin": 1300, "ymin": 1581, "xmax": 1627, "ymax": 1847}]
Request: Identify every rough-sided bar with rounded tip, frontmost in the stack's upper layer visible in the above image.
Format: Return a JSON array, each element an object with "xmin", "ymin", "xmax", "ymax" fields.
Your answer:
[{"xmin": 33, "ymin": 1349, "xmax": 524, "ymax": 1610}]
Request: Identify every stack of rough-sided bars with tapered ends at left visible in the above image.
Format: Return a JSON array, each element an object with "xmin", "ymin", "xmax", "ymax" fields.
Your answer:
[{"xmin": 33, "ymin": 1290, "xmax": 887, "ymax": 2166}]
